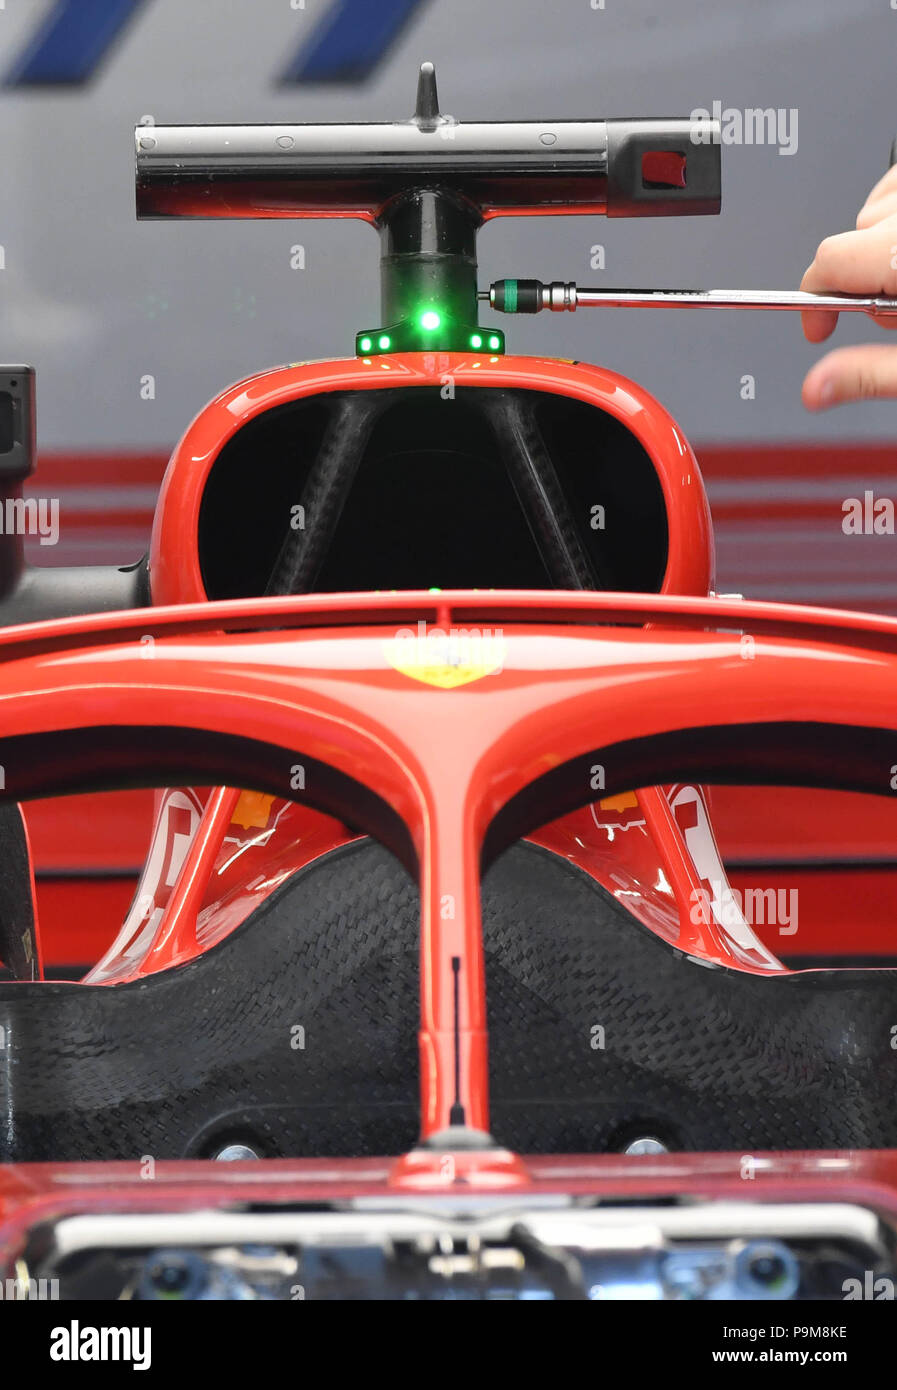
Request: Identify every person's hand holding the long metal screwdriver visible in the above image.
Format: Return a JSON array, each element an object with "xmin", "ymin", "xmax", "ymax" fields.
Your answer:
[{"xmin": 801, "ymin": 167, "xmax": 897, "ymax": 410}]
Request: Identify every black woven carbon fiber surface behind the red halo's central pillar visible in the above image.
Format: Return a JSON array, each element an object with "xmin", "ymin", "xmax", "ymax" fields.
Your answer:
[{"xmin": 0, "ymin": 841, "xmax": 897, "ymax": 1162}]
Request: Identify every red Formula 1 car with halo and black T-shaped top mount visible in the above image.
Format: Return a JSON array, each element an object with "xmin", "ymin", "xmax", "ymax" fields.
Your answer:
[{"xmin": 0, "ymin": 64, "xmax": 897, "ymax": 1300}]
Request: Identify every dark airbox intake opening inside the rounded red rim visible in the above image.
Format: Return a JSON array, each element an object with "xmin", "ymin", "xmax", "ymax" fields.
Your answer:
[{"xmin": 197, "ymin": 386, "xmax": 668, "ymax": 599}]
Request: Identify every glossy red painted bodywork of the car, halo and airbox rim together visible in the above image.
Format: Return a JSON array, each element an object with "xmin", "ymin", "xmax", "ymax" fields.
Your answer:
[{"xmin": 6, "ymin": 354, "xmax": 897, "ymax": 1244}]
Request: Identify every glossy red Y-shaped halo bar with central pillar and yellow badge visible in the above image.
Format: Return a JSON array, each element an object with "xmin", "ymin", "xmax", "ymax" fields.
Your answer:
[{"xmin": 0, "ymin": 581, "xmax": 897, "ymax": 1136}]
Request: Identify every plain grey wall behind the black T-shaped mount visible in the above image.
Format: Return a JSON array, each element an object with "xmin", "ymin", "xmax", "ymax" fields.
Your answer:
[{"xmin": 0, "ymin": 0, "xmax": 897, "ymax": 449}]
